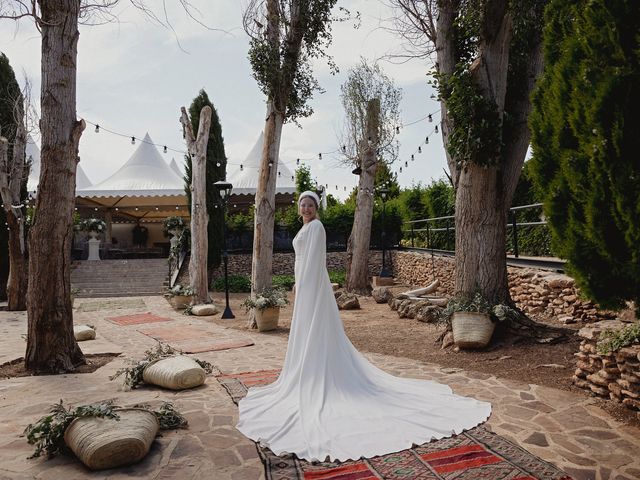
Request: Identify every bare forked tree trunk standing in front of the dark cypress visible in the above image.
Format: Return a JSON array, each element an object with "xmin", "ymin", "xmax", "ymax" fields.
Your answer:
[{"xmin": 180, "ymin": 105, "xmax": 211, "ymax": 303}]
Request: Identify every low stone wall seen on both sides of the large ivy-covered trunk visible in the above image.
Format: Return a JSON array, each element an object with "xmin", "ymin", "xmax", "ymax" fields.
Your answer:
[{"xmin": 393, "ymin": 251, "xmax": 615, "ymax": 324}]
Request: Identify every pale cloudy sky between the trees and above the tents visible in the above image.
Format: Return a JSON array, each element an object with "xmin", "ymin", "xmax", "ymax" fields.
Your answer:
[{"xmin": 0, "ymin": 0, "xmax": 446, "ymax": 198}]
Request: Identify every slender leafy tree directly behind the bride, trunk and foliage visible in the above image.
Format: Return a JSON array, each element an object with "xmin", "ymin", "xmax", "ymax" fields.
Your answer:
[{"xmin": 243, "ymin": 0, "xmax": 344, "ymax": 308}]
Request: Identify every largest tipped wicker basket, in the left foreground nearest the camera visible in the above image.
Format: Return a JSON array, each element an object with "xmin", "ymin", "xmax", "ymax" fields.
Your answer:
[{"xmin": 64, "ymin": 408, "xmax": 160, "ymax": 470}]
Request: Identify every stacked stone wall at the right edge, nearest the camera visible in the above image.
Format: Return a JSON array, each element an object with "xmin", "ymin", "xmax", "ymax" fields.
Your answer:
[{"xmin": 573, "ymin": 321, "xmax": 640, "ymax": 417}]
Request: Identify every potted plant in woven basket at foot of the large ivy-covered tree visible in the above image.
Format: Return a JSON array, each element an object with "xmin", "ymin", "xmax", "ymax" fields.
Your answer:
[{"xmin": 442, "ymin": 292, "xmax": 516, "ymax": 349}]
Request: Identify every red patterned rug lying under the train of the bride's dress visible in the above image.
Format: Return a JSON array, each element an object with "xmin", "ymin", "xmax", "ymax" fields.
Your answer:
[{"xmin": 217, "ymin": 370, "xmax": 571, "ymax": 480}]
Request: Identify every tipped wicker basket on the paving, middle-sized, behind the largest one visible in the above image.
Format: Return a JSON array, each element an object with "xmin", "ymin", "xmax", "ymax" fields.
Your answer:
[{"xmin": 142, "ymin": 355, "xmax": 207, "ymax": 390}]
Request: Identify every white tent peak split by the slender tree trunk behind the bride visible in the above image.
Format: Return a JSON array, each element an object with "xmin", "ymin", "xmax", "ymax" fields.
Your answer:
[{"xmin": 227, "ymin": 132, "xmax": 296, "ymax": 195}]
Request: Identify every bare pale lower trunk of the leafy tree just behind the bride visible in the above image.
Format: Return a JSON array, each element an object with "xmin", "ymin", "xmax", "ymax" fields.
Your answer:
[{"xmin": 251, "ymin": 105, "xmax": 284, "ymax": 295}]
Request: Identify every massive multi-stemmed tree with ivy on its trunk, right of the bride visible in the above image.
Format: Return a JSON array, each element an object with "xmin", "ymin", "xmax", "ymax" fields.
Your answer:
[{"xmin": 391, "ymin": 0, "xmax": 566, "ymax": 339}]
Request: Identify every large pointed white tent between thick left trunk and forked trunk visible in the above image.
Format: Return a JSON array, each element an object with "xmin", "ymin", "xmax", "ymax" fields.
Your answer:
[{"xmin": 76, "ymin": 134, "xmax": 188, "ymax": 221}]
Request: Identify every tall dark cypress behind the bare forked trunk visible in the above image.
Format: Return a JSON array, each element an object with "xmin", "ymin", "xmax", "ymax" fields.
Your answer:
[{"xmin": 184, "ymin": 89, "xmax": 227, "ymax": 271}]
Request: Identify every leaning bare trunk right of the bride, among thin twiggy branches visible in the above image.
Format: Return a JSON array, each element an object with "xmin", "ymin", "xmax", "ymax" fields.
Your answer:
[{"xmin": 345, "ymin": 99, "xmax": 380, "ymax": 295}]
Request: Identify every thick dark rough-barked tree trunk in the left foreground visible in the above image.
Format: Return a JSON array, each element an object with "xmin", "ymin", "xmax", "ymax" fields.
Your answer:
[{"xmin": 25, "ymin": 0, "xmax": 85, "ymax": 373}]
